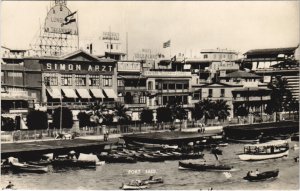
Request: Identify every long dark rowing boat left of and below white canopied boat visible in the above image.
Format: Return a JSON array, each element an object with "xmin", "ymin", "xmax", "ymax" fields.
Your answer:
[{"xmin": 179, "ymin": 161, "xmax": 233, "ymax": 171}]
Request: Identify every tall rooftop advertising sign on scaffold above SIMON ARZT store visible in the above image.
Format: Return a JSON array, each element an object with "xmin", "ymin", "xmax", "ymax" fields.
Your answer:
[{"xmin": 31, "ymin": 0, "xmax": 79, "ymax": 56}]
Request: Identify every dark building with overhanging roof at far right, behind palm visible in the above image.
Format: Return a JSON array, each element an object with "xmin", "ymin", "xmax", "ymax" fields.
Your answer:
[{"xmin": 242, "ymin": 46, "xmax": 300, "ymax": 100}]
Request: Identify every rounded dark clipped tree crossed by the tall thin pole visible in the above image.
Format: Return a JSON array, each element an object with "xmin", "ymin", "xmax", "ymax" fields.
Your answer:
[{"xmin": 52, "ymin": 107, "xmax": 74, "ymax": 129}]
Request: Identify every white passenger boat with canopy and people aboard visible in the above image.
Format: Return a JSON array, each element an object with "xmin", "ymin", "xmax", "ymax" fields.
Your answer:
[{"xmin": 239, "ymin": 140, "xmax": 289, "ymax": 161}]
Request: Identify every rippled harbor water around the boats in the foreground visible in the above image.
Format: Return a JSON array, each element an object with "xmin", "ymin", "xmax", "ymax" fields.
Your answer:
[{"xmin": 1, "ymin": 141, "xmax": 299, "ymax": 190}]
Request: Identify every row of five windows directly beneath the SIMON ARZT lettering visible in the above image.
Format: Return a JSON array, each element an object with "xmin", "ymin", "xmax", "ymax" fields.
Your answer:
[{"xmin": 44, "ymin": 74, "xmax": 112, "ymax": 87}]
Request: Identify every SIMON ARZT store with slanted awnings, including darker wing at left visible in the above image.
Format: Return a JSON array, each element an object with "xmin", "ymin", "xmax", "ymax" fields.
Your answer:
[{"xmin": 1, "ymin": 50, "xmax": 117, "ymax": 113}]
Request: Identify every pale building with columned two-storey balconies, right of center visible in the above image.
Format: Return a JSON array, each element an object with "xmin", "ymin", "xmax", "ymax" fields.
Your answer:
[{"xmin": 143, "ymin": 58, "xmax": 192, "ymax": 119}]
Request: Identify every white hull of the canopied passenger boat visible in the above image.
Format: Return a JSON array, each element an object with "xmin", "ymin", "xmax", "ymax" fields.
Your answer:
[{"xmin": 239, "ymin": 150, "xmax": 289, "ymax": 161}]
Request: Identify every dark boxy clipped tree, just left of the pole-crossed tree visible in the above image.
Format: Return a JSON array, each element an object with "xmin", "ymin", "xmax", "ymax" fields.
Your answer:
[{"xmin": 27, "ymin": 110, "xmax": 48, "ymax": 129}]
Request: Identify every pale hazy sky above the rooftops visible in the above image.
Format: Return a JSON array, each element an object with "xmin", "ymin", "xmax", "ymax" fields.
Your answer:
[{"xmin": 1, "ymin": 1, "xmax": 299, "ymax": 55}]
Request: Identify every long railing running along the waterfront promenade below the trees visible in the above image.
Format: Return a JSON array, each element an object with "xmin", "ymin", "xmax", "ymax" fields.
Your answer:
[{"xmin": 1, "ymin": 113, "xmax": 299, "ymax": 143}]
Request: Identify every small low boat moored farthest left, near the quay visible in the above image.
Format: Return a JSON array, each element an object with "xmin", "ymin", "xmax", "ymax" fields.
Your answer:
[{"xmin": 8, "ymin": 157, "xmax": 49, "ymax": 173}]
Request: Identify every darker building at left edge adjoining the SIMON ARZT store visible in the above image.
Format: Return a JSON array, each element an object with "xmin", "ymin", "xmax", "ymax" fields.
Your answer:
[{"xmin": 1, "ymin": 46, "xmax": 38, "ymax": 114}]
